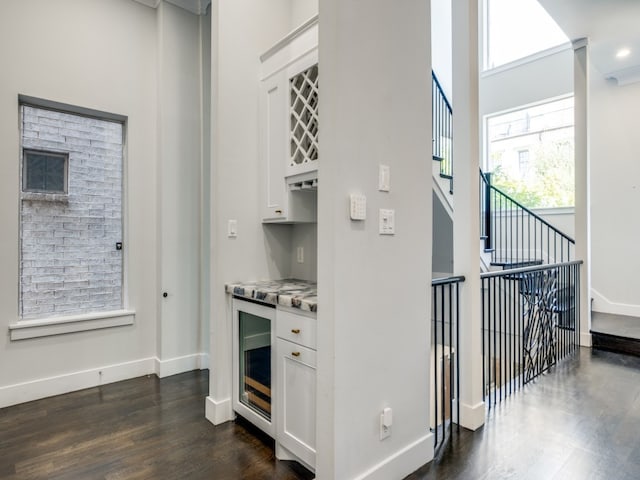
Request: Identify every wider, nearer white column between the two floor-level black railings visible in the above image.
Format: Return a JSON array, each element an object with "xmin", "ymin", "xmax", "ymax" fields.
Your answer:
[{"xmin": 452, "ymin": 0, "xmax": 485, "ymax": 430}]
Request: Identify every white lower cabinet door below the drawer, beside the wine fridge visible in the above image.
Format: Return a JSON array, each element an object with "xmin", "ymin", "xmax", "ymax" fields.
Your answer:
[{"xmin": 276, "ymin": 338, "xmax": 316, "ymax": 468}]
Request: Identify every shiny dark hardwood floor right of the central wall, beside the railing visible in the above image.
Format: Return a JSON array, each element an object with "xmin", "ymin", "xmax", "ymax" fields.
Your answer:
[{"xmin": 406, "ymin": 348, "xmax": 640, "ymax": 480}]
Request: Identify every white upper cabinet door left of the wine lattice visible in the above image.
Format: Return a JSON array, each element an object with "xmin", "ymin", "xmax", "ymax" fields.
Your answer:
[{"xmin": 260, "ymin": 71, "xmax": 288, "ymax": 221}]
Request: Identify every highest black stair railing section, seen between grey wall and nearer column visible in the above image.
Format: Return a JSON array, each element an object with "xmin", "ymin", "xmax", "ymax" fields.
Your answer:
[{"xmin": 431, "ymin": 71, "xmax": 453, "ymax": 193}]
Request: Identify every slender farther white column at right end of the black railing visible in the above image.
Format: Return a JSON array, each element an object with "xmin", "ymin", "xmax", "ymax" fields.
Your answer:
[{"xmin": 573, "ymin": 38, "xmax": 591, "ymax": 347}]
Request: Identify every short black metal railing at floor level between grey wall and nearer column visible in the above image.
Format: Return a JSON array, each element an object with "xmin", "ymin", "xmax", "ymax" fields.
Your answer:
[{"xmin": 430, "ymin": 276, "xmax": 464, "ymax": 451}]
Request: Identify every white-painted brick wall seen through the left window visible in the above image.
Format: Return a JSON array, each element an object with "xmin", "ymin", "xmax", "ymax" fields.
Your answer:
[{"xmin": 20, "ymin": 106, "xmax": 123, "ymax": 319}]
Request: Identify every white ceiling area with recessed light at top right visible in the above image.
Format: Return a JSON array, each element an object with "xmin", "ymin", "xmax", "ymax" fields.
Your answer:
[{"xmin": 538, "ymin": 0, "xmax": 640, "ymax": 85}]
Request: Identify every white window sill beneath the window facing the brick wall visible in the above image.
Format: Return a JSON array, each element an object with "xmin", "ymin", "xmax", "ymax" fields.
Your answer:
[{"xmin": 9, "ymin": 310, "xmax": 136, "ymax": 341}]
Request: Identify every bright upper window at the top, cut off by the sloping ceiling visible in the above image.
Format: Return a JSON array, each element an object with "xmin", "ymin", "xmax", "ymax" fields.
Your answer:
[{"xmin": 484, "ymin": 0, "xmax": 569, "ymax": 70}]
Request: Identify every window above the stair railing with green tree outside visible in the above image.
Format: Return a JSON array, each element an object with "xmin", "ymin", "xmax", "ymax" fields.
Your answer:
[{"xmin": 486, "ymin": 97, "xmax": 575, "ymax": 208}]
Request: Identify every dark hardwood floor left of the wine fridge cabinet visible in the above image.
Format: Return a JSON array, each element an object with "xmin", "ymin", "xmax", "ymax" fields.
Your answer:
[{"xmin": 0, "ymin": 371, "xmax": 313, "ymax": 480}]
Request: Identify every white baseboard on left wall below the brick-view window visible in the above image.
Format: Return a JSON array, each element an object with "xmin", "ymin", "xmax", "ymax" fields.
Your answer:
[{"xmin": 0, "ymin": 357, "xmax": 156, "ymax": 408}]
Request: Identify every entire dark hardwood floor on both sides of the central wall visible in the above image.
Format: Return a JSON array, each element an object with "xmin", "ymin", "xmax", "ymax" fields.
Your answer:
[{"xmin": 0, "ymin": 349, "xmax": 640, "ymax": 480}]
